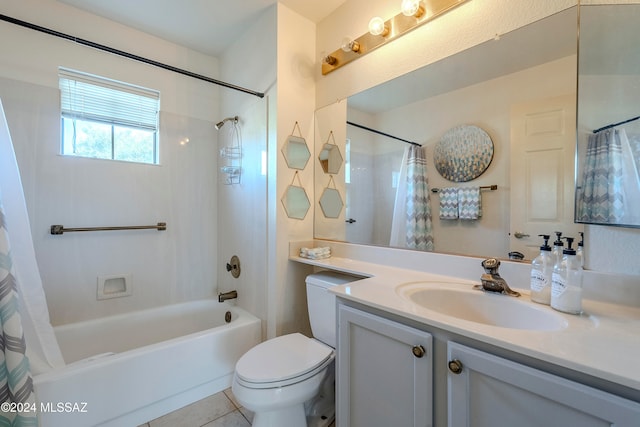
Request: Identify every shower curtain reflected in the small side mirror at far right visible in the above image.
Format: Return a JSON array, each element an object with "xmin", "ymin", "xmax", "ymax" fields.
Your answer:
[{"xmin": 577, "ymin": 128, "xmax": 638, "ymax": 224}]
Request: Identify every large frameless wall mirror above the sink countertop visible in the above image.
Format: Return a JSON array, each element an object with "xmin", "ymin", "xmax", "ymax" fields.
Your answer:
[{"xmin": 314, "ymin": 7, "xmax": 582, "ymax": 259}]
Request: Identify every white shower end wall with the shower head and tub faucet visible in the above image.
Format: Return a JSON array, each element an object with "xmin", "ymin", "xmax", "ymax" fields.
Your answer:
[{"xmin": 215, "ymin": 6, "xmax": 277, "ymax": 336}]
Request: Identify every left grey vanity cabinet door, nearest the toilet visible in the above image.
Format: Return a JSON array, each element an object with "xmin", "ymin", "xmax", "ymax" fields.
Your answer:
[{"xmin": 336, "ymin": 305, "xmax": 433, "ymax": 427}]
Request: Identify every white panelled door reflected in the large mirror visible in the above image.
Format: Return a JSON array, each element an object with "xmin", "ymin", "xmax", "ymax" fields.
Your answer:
[{"xmin": 509, "ymin": 93, "xmax": 583, "ymax": 259}]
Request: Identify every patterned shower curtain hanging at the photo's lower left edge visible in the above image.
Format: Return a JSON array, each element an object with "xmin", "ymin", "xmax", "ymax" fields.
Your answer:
[{"xmin": 0, "ymin": 200, "xmax": 38, "ymax": 427}]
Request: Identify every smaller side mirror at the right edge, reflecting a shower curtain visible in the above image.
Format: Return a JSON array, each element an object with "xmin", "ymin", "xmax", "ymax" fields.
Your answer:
[{"xmin": 575, "ymin": 4, "xmax": 640, "ymax": 227}]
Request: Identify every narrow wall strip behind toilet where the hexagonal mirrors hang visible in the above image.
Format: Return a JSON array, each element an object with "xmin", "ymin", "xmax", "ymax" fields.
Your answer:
[{"xmin": 267, "ymin": 3, "xmax": 316, "ymax": 337}]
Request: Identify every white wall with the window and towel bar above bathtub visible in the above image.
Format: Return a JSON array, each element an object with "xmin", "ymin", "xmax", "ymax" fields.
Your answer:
[{"xmin": 0, "ymin": 0, "xmax": 219, "ymax": 324}]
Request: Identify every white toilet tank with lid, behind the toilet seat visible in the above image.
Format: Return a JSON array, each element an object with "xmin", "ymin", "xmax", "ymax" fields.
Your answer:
[{"xmin": 306, "ymin": 271, "xmax": 361, "ymax": 348}]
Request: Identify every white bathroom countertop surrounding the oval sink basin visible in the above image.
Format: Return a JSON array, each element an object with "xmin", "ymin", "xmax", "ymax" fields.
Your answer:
[{"xmin": 290, "ymin": 256, "xmax": 640, "ymax": 391}]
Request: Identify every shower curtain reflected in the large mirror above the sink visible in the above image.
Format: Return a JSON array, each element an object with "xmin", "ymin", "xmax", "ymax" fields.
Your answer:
[{"xmin": 389, "ymin": 145, "xmax": 433, "ymax": 251}]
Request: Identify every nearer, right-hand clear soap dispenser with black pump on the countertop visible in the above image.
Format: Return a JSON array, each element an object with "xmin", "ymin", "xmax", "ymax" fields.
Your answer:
[{"xmin": 551, "ymin": 237, "xmax": 582, "ymax": 314}]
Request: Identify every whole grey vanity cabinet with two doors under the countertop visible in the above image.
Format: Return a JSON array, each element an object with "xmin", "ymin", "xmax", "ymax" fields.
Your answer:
[{"xmin": 336, "ymin": 299, "xmax": 640, "ymax": 427}]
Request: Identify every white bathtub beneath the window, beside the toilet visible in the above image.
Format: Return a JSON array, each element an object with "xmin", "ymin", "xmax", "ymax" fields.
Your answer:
[{"xmin": 34, "ymin": 300, "xmax": 261, "ymax": 427}]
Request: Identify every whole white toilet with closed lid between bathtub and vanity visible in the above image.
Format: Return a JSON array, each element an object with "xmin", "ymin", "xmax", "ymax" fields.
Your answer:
[{"xmin": 232, "ymin": 271, "xmax": 359, "ymax": 427}]
